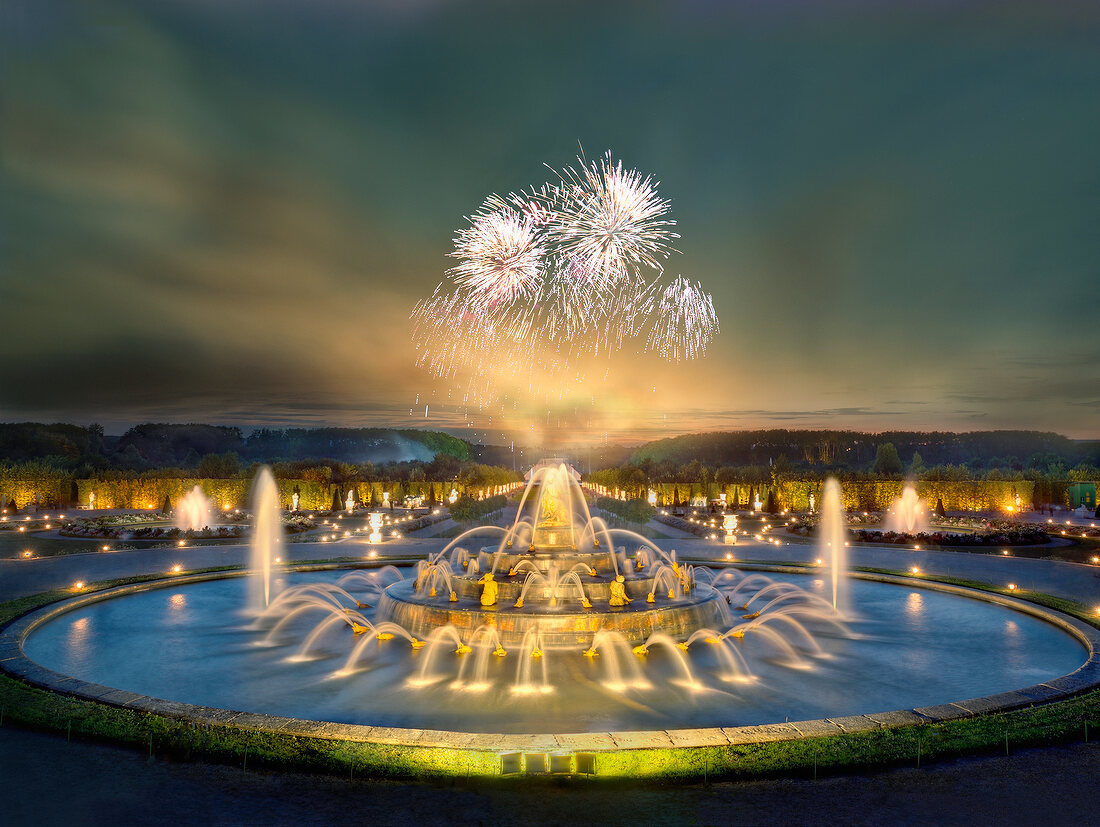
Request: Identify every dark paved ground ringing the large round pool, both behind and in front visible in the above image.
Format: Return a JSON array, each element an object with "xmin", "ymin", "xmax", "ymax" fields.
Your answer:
[{"xmin": 0, "ymin": 539, "xmax": 1100, "ymax": 827}]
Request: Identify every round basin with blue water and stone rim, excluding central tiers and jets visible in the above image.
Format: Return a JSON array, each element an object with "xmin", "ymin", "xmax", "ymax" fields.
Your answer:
[{"xmin": 12, "ymin": 574, "xmax": 1100, "ymax": 734}]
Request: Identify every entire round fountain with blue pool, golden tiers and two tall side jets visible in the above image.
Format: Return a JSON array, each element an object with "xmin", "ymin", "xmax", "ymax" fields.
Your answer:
[{"xmin": 19, "ymin": 462, "xmax": 1081, "ymax": 742}]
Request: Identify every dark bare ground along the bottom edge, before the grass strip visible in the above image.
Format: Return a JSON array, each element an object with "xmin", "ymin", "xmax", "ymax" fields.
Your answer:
[{"xmin": 0, "ymin": 726, "xmax": 1100, "ymax": 827}]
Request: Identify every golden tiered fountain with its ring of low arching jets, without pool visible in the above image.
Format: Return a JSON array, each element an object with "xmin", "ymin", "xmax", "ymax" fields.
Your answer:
[{"xmin": 253, "ymin": 461, "xmax": 845, "ymax": 693}]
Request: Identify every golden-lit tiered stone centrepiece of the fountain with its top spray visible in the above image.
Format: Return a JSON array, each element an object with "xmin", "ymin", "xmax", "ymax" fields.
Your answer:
[{"xmin": 375, "ymin": 462, "xmax": 728, "ymax": 649}]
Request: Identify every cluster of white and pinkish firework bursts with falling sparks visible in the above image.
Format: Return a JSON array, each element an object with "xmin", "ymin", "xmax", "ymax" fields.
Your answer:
[{"xmin": 411, "ymin": 153, "xmax": 718, "ymax": 407}]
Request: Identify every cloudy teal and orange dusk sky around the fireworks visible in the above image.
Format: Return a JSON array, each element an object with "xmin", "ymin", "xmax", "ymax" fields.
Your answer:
[{"xmin": 0, "ymin": 0, "xmax": 1100, "ymax": 441}]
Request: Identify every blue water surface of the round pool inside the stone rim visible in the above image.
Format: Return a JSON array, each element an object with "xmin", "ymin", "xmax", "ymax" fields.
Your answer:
[{"xmin": 23, "ymin": 572, "xmax": 1087, "ymax": 732}]
